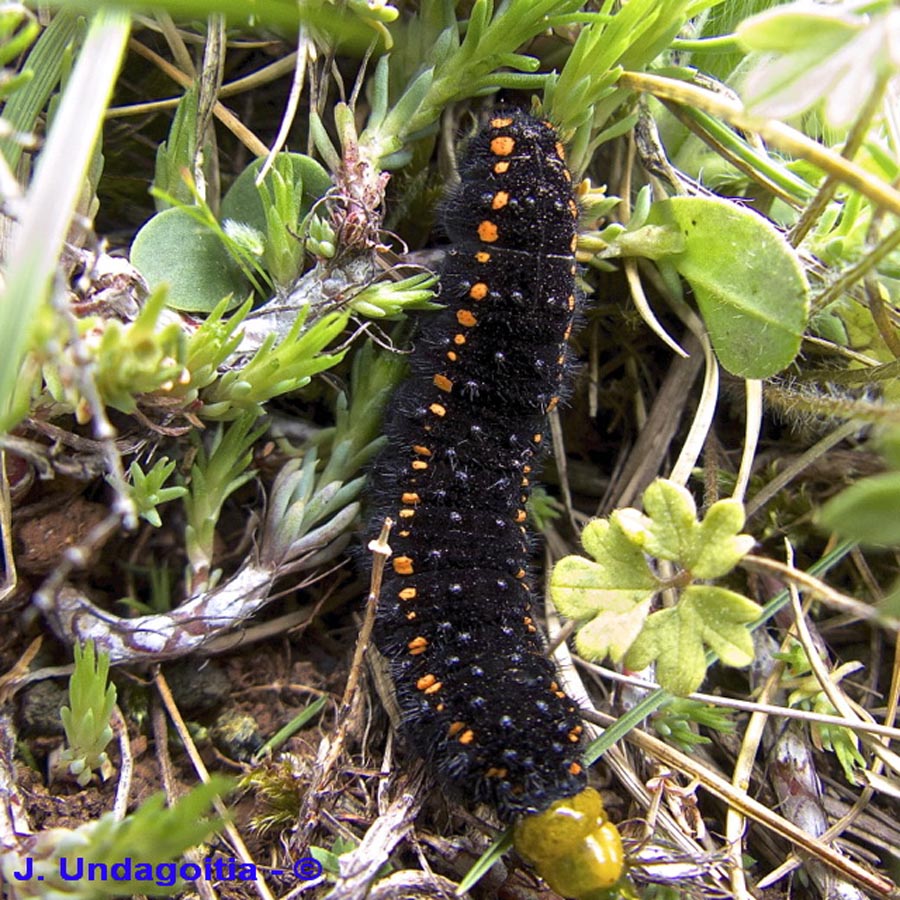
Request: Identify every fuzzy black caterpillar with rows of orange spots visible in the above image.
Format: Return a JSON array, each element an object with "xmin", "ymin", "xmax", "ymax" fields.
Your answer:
[{"xmin": 371, "ymin": 110, "xmax": 586, "ymax": 820}]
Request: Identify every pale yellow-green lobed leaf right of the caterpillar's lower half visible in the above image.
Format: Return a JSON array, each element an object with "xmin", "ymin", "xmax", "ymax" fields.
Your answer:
[{"xmin": 550, "ymin": 479, "xmax": 758, "ymax": 668}]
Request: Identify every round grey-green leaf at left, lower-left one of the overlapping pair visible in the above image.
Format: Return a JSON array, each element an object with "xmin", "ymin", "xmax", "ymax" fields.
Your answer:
[{"xmin": 131, "ymin": 208, "xmax": 251, "ymax": 313}]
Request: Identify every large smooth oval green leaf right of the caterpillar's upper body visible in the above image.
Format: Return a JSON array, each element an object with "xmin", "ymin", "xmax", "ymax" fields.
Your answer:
[{"xmin": 647, "ymin": 197, "xmax": 809, "ymax": 378}]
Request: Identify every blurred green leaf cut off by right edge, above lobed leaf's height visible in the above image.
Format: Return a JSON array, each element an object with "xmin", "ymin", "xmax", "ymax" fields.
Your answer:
[{"xmin": 819, "ymin": 472, "xmax": 900, "ymax": 547}]
